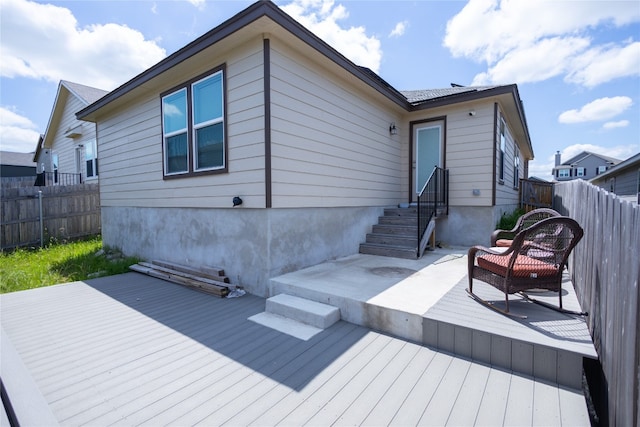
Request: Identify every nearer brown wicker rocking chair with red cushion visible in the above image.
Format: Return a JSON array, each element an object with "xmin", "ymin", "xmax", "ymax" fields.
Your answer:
[{"xmin": 467, "ymin": 216, "xmax": 586, "ymax": 317}]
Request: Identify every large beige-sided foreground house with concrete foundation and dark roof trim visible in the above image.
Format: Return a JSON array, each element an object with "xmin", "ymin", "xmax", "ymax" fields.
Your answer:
[{"xmin": 77, "ymin": 1, "xmax": 533, "ymax": 296}]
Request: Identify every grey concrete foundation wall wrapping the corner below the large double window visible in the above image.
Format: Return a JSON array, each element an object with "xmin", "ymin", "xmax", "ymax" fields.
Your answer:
[{"xmin": 102, "ymin": 207, "xmax": 384, "ymax": 297}]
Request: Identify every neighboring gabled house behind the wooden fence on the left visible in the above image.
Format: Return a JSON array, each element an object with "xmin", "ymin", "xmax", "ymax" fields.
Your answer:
[{"xmin": 33, "ymin": 80, "xmax": 108, "ymax": 185}]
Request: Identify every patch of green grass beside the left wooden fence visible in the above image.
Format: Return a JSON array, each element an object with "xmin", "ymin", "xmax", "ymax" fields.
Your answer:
[{"xmin": 0, "ymin": 236, "xmax": 139, "ymax": 293}]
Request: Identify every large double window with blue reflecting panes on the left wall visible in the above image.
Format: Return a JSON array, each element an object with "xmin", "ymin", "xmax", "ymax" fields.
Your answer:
[{"xmin": 162, "ymin": 69, "xmax": 227, "ymax": 177}]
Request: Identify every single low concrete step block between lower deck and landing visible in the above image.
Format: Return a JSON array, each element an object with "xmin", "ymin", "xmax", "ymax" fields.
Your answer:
[{"xmin": 265, "ymin": 294, "xmax": 340, "ymax": 329}]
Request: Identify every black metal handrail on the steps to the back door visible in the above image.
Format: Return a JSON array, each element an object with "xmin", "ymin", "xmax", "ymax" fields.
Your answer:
[{"xmin": 417, "ymin": 166, "xmax": 449, "ymax": 256}]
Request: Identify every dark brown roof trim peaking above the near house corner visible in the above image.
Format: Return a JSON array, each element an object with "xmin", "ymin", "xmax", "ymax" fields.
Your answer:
[{"xmin": 76, "ymin": 0, "xmax": 410, "ymax": 119}]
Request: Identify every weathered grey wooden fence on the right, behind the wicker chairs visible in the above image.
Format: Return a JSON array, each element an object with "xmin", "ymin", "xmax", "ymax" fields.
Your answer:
[{"xmin": 554, "ymin": 180, "xmax": 640, "ymax": 426}]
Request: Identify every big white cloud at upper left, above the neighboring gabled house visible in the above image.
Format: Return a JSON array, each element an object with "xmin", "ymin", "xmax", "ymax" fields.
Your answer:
[{"xmin": 0, "ymin": 0, "xmax": 166, "ymax": 90}]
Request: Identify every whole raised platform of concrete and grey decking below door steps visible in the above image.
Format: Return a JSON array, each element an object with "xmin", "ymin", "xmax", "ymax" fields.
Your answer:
[{"xmin": 270, "ymin": 248, "xmax": 597, "ymax": 389}]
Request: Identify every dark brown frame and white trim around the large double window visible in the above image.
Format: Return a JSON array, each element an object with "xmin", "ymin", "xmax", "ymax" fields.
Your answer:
[{"xmin": 160, "ymin": 64, "xmax": 229, "ymax": 180}]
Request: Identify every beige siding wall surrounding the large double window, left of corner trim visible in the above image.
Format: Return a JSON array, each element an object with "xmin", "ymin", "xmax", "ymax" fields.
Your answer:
[{"xmin": 94, "ymin": 39, "xmax": 265, "ymax": 208}]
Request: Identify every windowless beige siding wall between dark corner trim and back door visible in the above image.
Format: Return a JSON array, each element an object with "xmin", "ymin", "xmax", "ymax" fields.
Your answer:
[{"xmin": 271, "ymin": 40, "xmax": 407, "ymax": 207}]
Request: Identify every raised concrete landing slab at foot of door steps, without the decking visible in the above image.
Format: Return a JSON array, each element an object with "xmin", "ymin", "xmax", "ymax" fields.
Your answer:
[{"xmin": 270, "ymin": 249, "xmax": 466, "ymax": 342}]
